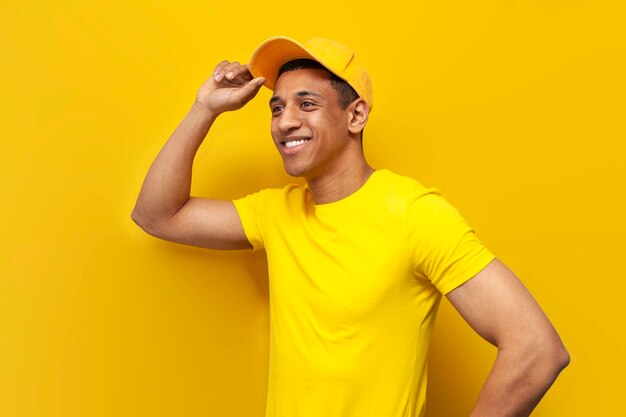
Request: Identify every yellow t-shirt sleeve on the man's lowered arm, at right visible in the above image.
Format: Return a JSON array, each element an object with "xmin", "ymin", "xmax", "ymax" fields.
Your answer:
[{"xmin": 411, "ymin": 189, "xmax": 495, "ymax": 295}]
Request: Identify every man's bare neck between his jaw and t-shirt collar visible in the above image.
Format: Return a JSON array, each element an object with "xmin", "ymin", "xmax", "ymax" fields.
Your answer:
[{"xmin": 306, "ymin": 160, "xmax": 374, "ymax": 204}]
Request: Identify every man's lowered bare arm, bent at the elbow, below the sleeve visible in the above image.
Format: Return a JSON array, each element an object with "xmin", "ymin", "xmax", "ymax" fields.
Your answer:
[{"xmin": 447, "ymin": 259, "xmax": 569, "ymax": 417}]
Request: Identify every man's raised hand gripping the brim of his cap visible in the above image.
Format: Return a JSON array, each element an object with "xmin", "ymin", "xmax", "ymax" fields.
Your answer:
[{"xmin": 196, "ymin": 61, "xmax": 265, "ymax": 115}]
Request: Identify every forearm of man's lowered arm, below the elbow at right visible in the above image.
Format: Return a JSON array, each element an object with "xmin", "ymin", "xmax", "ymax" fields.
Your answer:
[{"xmin": 470, "ymin": 342, "xmax": 569, "ymax": 417}]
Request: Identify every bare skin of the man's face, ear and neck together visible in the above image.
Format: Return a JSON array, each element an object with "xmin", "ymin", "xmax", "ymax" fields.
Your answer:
[{"xmin": 270, "ymin": 69, "xmax": 374, "ymax": 204}]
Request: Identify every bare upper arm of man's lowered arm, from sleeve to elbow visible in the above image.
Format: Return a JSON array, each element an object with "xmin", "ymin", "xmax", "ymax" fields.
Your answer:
[{"xmin": 446, "ymin": 259, "xmax": 560, "ymax": 348}]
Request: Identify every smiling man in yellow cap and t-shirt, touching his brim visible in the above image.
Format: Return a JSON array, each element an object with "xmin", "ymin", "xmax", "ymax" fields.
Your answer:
[{"xmin": 132, "ymin": 37, "xmax": 569, "ymax": 417}]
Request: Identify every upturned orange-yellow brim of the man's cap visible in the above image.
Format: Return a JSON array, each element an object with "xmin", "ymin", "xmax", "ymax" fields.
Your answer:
[{"xmin": 248, "ymin": 36, "xmax": 316, "ymax": 90}]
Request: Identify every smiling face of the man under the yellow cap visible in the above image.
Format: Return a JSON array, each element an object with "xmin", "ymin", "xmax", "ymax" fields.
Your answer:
[{"xmin": 270, "ymin": 69, "xmax": 360, "ymax": 179}]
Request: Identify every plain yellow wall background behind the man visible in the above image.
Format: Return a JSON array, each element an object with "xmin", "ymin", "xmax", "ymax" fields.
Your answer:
[{"xmin": 0, "ymin": 0, "xmax": 626, "ymax": 417}]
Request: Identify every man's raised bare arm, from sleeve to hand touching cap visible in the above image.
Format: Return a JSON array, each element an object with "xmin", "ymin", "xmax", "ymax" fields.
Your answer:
[{"xmin": 131, "ymin": 61, "xmax": 265, "ymax": 249}]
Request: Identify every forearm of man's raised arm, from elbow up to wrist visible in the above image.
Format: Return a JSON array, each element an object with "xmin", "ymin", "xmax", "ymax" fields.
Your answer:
[{"xmin": 132, "ymin": 102, "xmax": 216, "ymax": 228}]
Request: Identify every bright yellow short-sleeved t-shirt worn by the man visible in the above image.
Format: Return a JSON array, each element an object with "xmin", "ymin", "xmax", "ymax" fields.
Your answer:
[{"xmin": 234, "ymin": 170, "xmax": 494, "ymax": 417}]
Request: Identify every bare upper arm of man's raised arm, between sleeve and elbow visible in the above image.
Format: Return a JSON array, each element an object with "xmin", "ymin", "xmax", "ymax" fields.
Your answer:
[{"xmin": 147, "ymin": 197, "xmax": 252, "ymax": 249}]
